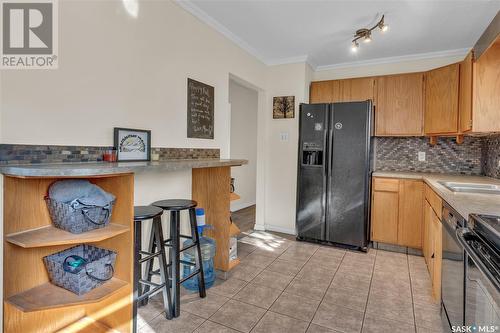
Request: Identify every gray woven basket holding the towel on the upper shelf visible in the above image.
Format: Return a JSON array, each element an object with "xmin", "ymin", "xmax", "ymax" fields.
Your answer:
[{"xmin": 45, "ymin": 197, "xmax": 115, "ymax": 234}]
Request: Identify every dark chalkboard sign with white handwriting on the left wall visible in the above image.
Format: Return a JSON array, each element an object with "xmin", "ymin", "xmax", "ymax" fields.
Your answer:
[{"xmin": 187, "ymin": 78, "xmax": 214, "ymax": 139}]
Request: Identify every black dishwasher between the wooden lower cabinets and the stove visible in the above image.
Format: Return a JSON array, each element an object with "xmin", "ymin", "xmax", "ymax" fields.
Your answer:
[{"xmin": 441, "ymin": 202, "xmax": 466, "ymax": 328}]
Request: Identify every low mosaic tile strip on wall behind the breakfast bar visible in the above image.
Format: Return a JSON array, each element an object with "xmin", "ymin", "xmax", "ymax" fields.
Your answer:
[{"xmin": 0, "ymin": 144, "xmax": 220, "ymax": 164}]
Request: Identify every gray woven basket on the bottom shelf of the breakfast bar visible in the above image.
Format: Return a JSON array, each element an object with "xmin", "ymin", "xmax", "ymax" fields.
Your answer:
[{"xmin": 43, "ymin": 244, "xmax": 116, "ymax": 295}]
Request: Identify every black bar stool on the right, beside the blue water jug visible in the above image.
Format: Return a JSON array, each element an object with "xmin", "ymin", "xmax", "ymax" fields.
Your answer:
[{"xmin": 152, "ymin": 199, "xmax": 206, "ymax": 317}]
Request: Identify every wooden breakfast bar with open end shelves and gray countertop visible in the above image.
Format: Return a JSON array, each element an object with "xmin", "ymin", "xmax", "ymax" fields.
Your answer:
[{"xmin": 0, "ymin": 159, "xmax": 248, "ymax": 332}]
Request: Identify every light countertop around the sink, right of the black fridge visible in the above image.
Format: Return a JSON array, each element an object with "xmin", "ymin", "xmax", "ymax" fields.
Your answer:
[{"xmin": 372, "ymin": 171, "xmax": 500, "ymax": 219}]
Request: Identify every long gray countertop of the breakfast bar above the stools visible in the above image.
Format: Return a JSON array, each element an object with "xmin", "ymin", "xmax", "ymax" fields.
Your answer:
[{"xmin": 0, "ymin": 159, "xmax": 248, "ymax": 177}]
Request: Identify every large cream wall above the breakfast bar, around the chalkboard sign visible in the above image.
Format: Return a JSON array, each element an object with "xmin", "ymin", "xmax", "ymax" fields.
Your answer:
[{"xmin": 1, "ymin": 0, "xmax": 266, "ymax": 157}]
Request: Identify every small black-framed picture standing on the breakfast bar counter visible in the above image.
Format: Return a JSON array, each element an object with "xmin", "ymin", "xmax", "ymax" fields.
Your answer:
[{"xmin": 114, "ymin": 127, "xmax": 151, "ymax": 162}]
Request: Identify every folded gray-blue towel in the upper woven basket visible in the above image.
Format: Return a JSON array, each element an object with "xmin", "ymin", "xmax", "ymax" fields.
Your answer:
[{"xmin": 49, "ymin": 179, "xmax": 115, "ymax": 208}]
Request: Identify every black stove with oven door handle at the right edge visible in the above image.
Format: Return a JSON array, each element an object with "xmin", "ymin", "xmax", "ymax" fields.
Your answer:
[{"xmin": 457, "ymin": 214, "xmax": 500, "ymax": 332}]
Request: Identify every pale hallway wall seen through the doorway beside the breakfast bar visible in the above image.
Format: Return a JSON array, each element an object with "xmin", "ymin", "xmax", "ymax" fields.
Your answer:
[{"xmin": 229, "ymin": 80, "xmax": 259, "ymax": 211}]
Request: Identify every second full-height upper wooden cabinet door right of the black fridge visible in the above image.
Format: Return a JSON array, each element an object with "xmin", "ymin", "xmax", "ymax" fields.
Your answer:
[{"xmin": 424, "ymin": 64, "xmax": 459, "ymax": 135}]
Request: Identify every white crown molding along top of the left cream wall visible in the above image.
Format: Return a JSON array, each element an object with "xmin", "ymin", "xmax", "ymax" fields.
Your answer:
[{"xmin": 175, "ymin": 0, "xmax": 268, "ymax": 65}]
